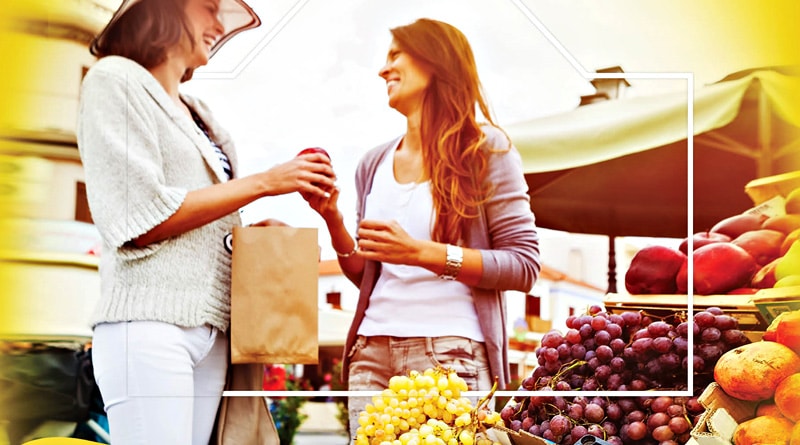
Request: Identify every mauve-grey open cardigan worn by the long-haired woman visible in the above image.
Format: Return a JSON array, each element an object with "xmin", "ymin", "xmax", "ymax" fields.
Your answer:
[{"xmin": 342, "ymin": 126, "xmax": 541, "ymax": 389}]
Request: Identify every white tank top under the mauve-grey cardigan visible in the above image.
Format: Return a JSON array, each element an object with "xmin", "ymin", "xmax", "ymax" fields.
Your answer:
[{"xmin": 358, "ymin": 147, "xmax": 483, "ymax": 342}]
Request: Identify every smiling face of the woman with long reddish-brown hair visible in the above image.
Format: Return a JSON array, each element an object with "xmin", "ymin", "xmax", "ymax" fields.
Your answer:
[{"xmin": 378, "ymin": 40, "xmax": 431, "ymax": 116}]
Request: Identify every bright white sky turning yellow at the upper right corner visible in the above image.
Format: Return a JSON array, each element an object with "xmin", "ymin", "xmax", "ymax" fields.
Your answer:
[{"xmin": 184, "ymin": 0, "xmax": 800, "ymax": 266}]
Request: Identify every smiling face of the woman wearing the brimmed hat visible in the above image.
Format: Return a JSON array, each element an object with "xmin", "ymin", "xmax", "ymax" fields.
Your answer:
[{"xmin": 179, "ymin": 0, "xmax": 225, "ymax": 68}]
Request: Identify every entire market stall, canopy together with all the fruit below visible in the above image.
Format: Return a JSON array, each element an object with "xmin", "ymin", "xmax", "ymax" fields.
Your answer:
[{"xmin": 357, "ymin": 69, "xmax": 800, "ymax": 445}]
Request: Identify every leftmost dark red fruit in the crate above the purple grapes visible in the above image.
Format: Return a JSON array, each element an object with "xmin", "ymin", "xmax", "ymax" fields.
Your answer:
[{"xmin": 625, "ymin": 246, "xmax": 686, "ymax": 295}]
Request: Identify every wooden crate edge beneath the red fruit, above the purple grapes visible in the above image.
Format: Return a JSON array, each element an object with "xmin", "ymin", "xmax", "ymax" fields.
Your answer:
[{"xmin": 604, "ymin": 293, "xmax": 769, "ymax": 341}]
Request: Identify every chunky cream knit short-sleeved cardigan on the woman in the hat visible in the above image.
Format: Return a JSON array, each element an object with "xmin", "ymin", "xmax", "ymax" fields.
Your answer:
[{"xmin": 77, "ymin": 56, "xmax": 241, "ymax": 331}]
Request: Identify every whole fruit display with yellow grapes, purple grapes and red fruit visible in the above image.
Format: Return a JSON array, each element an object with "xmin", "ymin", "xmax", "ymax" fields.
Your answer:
[{"xmin": 354, "ymin": 171, "xmax": 800, "ymax": 445}]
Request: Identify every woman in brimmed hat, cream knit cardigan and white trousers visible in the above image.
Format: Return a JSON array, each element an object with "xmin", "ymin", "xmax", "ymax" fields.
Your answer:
[{"xmin": 77, "ymin": 0, "xmax": 335, "ymax": 445}]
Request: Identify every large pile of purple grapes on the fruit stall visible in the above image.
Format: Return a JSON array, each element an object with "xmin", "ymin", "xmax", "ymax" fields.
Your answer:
[{"xmin": 501, "ymin": 305, "xmax": 750, "ymax": 445}]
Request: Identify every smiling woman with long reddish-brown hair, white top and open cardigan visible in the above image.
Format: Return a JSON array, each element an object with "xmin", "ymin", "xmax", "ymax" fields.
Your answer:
[{"xmin": 304, "ymin": 19, "xmax": 540, "ymax": 437}]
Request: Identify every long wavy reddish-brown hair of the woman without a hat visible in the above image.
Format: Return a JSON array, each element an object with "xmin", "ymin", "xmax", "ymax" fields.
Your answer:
[{"xmin": 391, "ymin": 18, "xmax": 504, "ymax": 244}]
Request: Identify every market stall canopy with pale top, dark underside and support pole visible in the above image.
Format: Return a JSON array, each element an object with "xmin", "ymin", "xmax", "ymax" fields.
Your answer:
[{"xmin": 506, "ymin": 67, "xmax": 800, "ymax": 292}]
